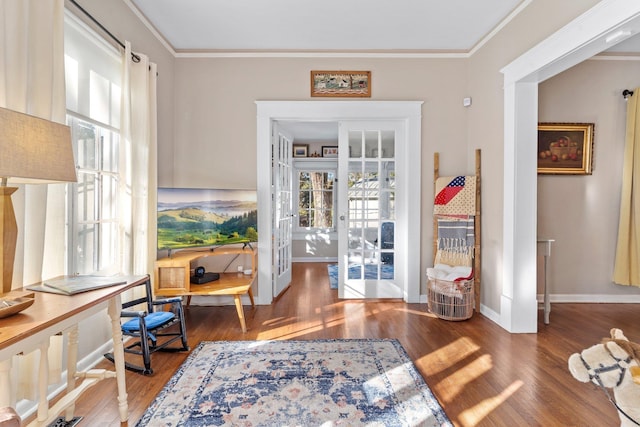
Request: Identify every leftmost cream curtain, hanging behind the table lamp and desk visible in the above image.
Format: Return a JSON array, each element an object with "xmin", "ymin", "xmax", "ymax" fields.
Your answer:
[{"xmin": 0, "ymin": 0, "xmax": 66, "ymax": 399}]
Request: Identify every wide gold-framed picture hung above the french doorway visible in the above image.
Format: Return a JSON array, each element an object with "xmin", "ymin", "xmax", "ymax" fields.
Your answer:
[{"xmin": 311, "ymin": 71, "xmax": 371, "ymax": 98}]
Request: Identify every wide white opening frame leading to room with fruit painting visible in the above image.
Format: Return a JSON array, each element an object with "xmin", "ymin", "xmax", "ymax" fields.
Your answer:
[{"xmin": 499, "ymin": 0, "xmax": 640, "ymax": 333}]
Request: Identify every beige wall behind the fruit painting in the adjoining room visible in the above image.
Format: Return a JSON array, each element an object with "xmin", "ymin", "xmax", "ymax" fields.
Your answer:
[{"xmin": 538, "ymin": 59, "xmax": 640, "ymax": 301}]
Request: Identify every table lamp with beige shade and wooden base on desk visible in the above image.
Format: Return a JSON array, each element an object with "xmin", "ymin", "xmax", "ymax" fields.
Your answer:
[{"xmin": 0, "ymin": 108, "xmax": 77, "ymax": 293}]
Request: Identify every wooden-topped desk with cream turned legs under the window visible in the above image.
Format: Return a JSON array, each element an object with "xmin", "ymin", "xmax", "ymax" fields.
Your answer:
[{"xmin": 0, "ymin": 276, "xmax": 148, "ymax": 426}]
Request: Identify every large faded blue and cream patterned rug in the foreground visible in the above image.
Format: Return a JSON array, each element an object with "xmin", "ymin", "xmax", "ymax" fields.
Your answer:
[{"xmin": 136, "ymin": 339, "xmax": 453, "ymax": 427}]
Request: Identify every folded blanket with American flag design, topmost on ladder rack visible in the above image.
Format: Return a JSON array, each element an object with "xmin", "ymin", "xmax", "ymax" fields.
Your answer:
[{"xmin": 433, "ymin": 176, "xmax": 476, "ymax": 217}]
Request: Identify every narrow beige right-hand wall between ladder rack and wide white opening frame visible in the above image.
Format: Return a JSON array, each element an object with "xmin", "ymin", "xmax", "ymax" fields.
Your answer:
[{"xmin": 467, "ymin": 0, "xmax": 598, "ymax": 313}]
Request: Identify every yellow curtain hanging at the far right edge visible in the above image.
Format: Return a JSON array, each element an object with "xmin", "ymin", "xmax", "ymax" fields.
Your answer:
[{"xmin": 613, "ymin": 88, "xmax": 640, "ymax": 286}]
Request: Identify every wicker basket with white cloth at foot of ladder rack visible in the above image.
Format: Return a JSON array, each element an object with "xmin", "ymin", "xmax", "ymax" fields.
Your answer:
[{"xmin": 428, "ymin": 279, "xmax": 475, "ymax": 320}]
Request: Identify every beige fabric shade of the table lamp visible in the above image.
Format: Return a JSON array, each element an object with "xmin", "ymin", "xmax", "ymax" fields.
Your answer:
[{"xmin": 0, "ymin": 108, "xmax": 77, "ymax": 182}]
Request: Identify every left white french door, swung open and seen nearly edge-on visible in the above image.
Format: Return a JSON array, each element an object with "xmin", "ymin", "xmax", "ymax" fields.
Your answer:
[{"xmin": 272, "ymin": 123, "xmax": 293, "ymax": 297}]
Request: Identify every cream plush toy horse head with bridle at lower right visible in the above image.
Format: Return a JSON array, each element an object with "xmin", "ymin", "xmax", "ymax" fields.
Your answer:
[{"xmin": 569, "ymin": 329, "xmax": 640, "ymax": 427}]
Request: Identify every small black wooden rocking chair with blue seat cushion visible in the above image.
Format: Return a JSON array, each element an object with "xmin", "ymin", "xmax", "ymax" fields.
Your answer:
[{"xmin": 104, "ymin": 277, "xmax": 189, "ymax": 375}]
